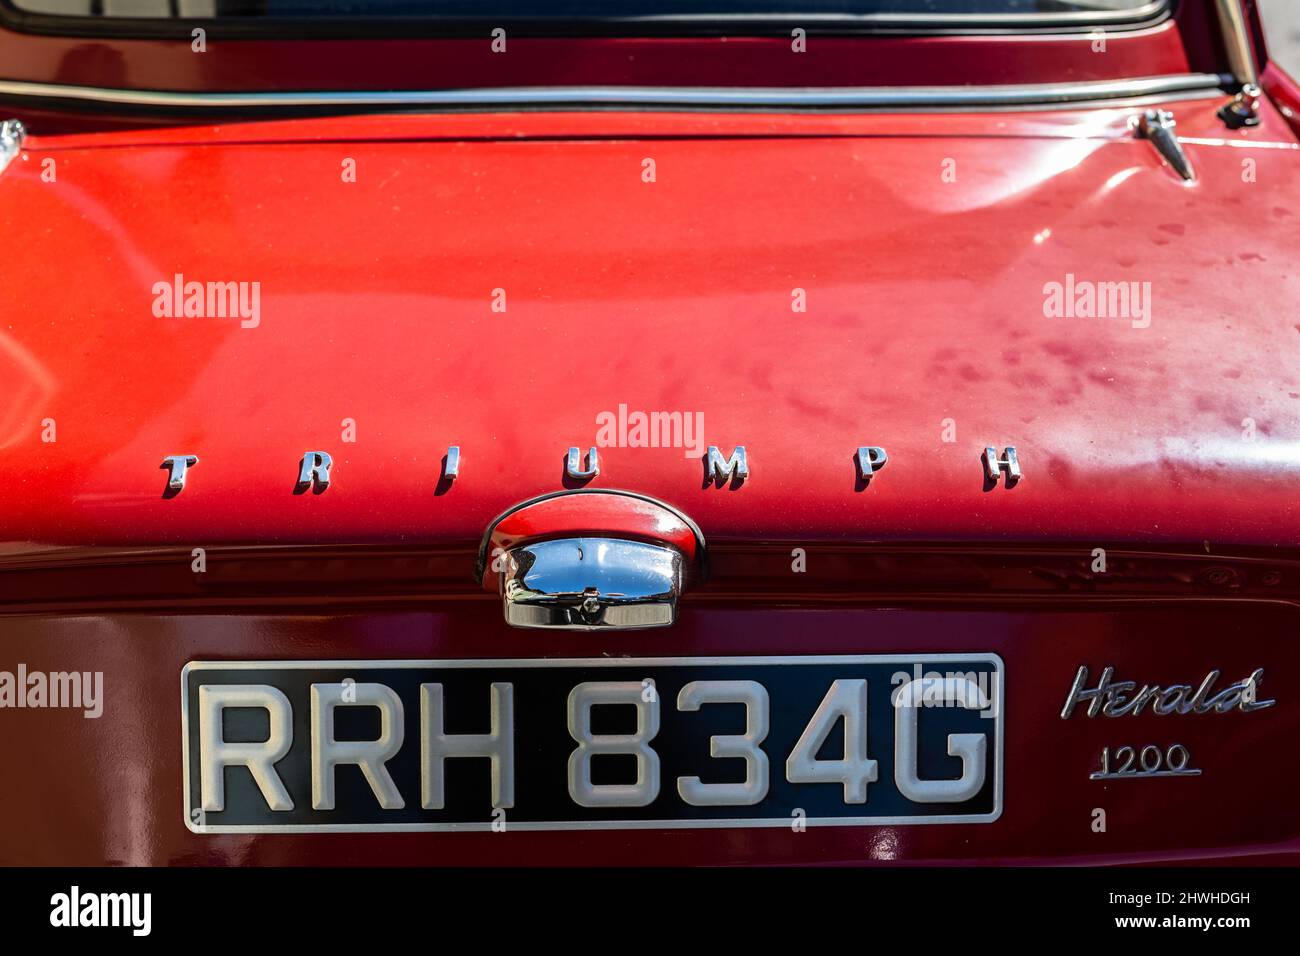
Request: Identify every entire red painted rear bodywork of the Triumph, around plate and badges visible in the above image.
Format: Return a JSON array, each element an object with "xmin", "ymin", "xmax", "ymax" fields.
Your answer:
[{"xmin": 0, "ymin": 5, "xmax": 1300, "ymax": 864}]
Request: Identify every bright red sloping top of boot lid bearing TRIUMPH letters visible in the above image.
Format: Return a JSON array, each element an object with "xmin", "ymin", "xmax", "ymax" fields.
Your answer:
[{"xmin": 0, "ymin": 99, "xmax": 1300, "ymax": 556}]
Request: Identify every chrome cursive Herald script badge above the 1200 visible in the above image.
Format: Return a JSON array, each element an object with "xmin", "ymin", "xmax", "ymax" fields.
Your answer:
[{"xmin": 1061, "ymin": 667, "xmax": 1277, "ymax": 721}]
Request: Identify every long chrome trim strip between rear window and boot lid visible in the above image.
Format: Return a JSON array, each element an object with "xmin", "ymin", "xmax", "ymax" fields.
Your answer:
[{"xmin": 0, "ymin": 73, "xmax": 1223, "ymax": 109}]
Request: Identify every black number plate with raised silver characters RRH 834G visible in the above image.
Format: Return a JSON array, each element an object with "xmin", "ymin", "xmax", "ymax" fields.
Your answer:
[{"xmin": 181, "ymin": 654, "xmax": 1004, "ymax": 832}]
